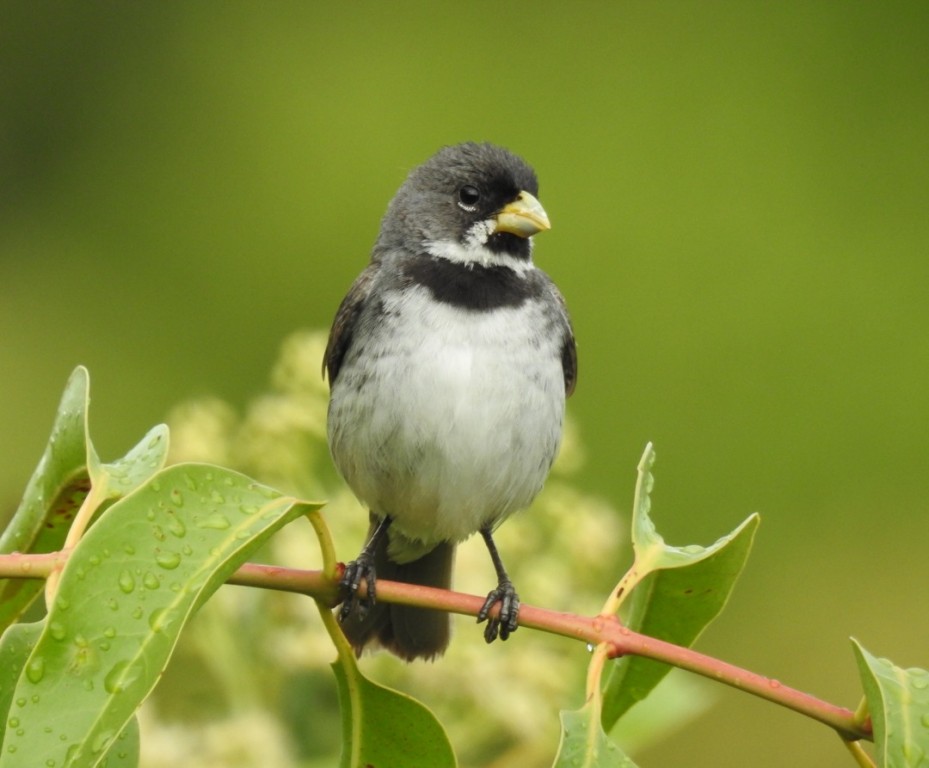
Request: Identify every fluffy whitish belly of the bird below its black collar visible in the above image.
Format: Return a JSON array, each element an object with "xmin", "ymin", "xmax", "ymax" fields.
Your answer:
[{"xmin": 329, "ymin": 290, "xmax": 564, "ymax": 557}]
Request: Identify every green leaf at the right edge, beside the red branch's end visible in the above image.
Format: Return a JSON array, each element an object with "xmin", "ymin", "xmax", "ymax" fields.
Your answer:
[{"xmin": 852, "ymin": 639, "xmax": 929, "ymax": 768}]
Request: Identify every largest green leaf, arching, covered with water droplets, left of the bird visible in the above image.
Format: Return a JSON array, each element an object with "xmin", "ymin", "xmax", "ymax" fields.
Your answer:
[{"xmin": 0, "ymin": 464, "xmax": 318, "ymax": 768}]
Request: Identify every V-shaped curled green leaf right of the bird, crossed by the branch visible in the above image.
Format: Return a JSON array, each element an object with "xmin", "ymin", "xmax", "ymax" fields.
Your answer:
[{"xmin": 603, "ymin": 445, "xmax": 760, "ymax": 732}]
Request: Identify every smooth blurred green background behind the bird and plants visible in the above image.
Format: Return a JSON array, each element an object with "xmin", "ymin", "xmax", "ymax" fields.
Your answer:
[{"xmin": 0, "ymin": 2, "xmax": 929, "ymax": 766}]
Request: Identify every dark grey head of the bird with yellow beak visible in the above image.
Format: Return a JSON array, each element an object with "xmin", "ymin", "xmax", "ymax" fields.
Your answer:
[{"xmin": 375, "ymin": 142, "xmax": 550, "ymax": 263}]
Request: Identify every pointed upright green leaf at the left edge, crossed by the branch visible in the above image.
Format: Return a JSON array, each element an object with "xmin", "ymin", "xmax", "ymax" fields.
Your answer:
[{"xmin": 0, "ymin": 367, "xmax": 90, "ymax": 629}]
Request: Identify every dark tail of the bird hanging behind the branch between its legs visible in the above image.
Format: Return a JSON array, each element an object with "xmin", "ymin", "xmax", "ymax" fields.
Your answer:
[{"xmin": 340, "ymin": 532, "xmax": 455, "ymax": 661}]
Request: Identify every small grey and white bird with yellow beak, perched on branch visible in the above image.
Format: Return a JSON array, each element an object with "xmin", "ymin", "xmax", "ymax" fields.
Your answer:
[{"xmin": 323, "ymin": 143, "xmax": 577, "ymax": 661}]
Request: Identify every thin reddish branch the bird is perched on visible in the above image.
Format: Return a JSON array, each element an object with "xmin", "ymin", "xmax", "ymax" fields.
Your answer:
[{"xmin": 0, "ymin": 552, "xmax": 873, "ymax": 742}]
